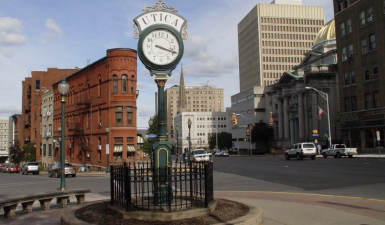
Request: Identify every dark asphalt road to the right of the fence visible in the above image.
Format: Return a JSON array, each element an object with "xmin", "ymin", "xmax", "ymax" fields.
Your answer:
[{"xmin": 214, "ymin": 156, "xmax": 385, "ymax": 200}]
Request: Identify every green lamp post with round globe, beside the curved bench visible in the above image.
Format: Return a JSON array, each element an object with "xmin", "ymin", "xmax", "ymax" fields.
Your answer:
[{"xmin": 58, "ymin": 78, "xmax": 70, "ymax": 191}]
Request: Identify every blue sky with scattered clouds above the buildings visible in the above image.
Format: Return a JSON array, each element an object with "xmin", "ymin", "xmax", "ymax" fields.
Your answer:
[{"xmin": 0, "ymin": 0, "xmax": 333, "ymax": 128}]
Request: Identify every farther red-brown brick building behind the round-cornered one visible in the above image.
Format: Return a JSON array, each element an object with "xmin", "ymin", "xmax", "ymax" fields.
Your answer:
[{"xmin": 17, "ymin": 68, "xmax": 79, "ymax": 161}]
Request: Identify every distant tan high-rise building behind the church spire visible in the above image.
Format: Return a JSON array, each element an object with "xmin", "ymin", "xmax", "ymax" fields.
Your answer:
[{"xmin": 165, "ymin": 71, "xmax": 224, "ymax": 141}]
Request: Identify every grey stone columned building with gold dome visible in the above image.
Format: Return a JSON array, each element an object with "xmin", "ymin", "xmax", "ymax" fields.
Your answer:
[{"xmin": 231, "ymin": 20, "xmax": 341, "ymax": 151}]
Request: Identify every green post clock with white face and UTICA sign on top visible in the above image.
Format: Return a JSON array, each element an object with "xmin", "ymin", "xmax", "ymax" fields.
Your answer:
[{"xmin": 133, "ymin": 0, "xmax": 188, "ymax": 205}]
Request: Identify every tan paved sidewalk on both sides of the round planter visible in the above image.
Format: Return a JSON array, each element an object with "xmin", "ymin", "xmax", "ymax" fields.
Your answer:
[{"xmin": 0, "ymin": 191, "xmax": 385, "ymax": 225}]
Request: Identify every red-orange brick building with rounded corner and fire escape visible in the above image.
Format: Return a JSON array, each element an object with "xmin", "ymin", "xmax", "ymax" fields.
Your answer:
[{"xmin": 53, "ymin": 48, "xmax": 137, "ymax": 169}]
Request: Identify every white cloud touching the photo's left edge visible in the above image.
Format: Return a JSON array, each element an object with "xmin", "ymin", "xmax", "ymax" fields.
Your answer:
[{"xmin": 0, "ymin": 17, "xmax": 27, "ymax": 46}]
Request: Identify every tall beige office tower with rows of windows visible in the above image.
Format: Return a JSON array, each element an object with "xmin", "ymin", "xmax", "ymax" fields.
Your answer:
[{"xmin": 238, "ymin": 0, "xmax": 324, "ymax": 91}]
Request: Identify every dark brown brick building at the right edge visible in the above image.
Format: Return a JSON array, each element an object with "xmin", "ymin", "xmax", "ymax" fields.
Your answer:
[{"xmin": 333, "ymin": 0, "xmax": 385, "ymax": 153}]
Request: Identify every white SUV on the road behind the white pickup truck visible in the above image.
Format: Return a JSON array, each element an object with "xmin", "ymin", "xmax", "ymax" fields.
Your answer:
[{"xmin": 285, "ymin": 142, "xmax": 317, "ymax": 160}]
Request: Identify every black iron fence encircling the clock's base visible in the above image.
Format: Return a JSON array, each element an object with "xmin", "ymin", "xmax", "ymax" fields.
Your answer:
[{"xmin": 110, "ymin": 162, "xmax": 214, "ymax": 212}]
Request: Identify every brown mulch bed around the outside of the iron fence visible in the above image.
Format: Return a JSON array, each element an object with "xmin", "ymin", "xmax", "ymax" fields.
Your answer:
[{"xmin": 75, "ymin": 199, "xmax": 250, "ymax": 225}]
